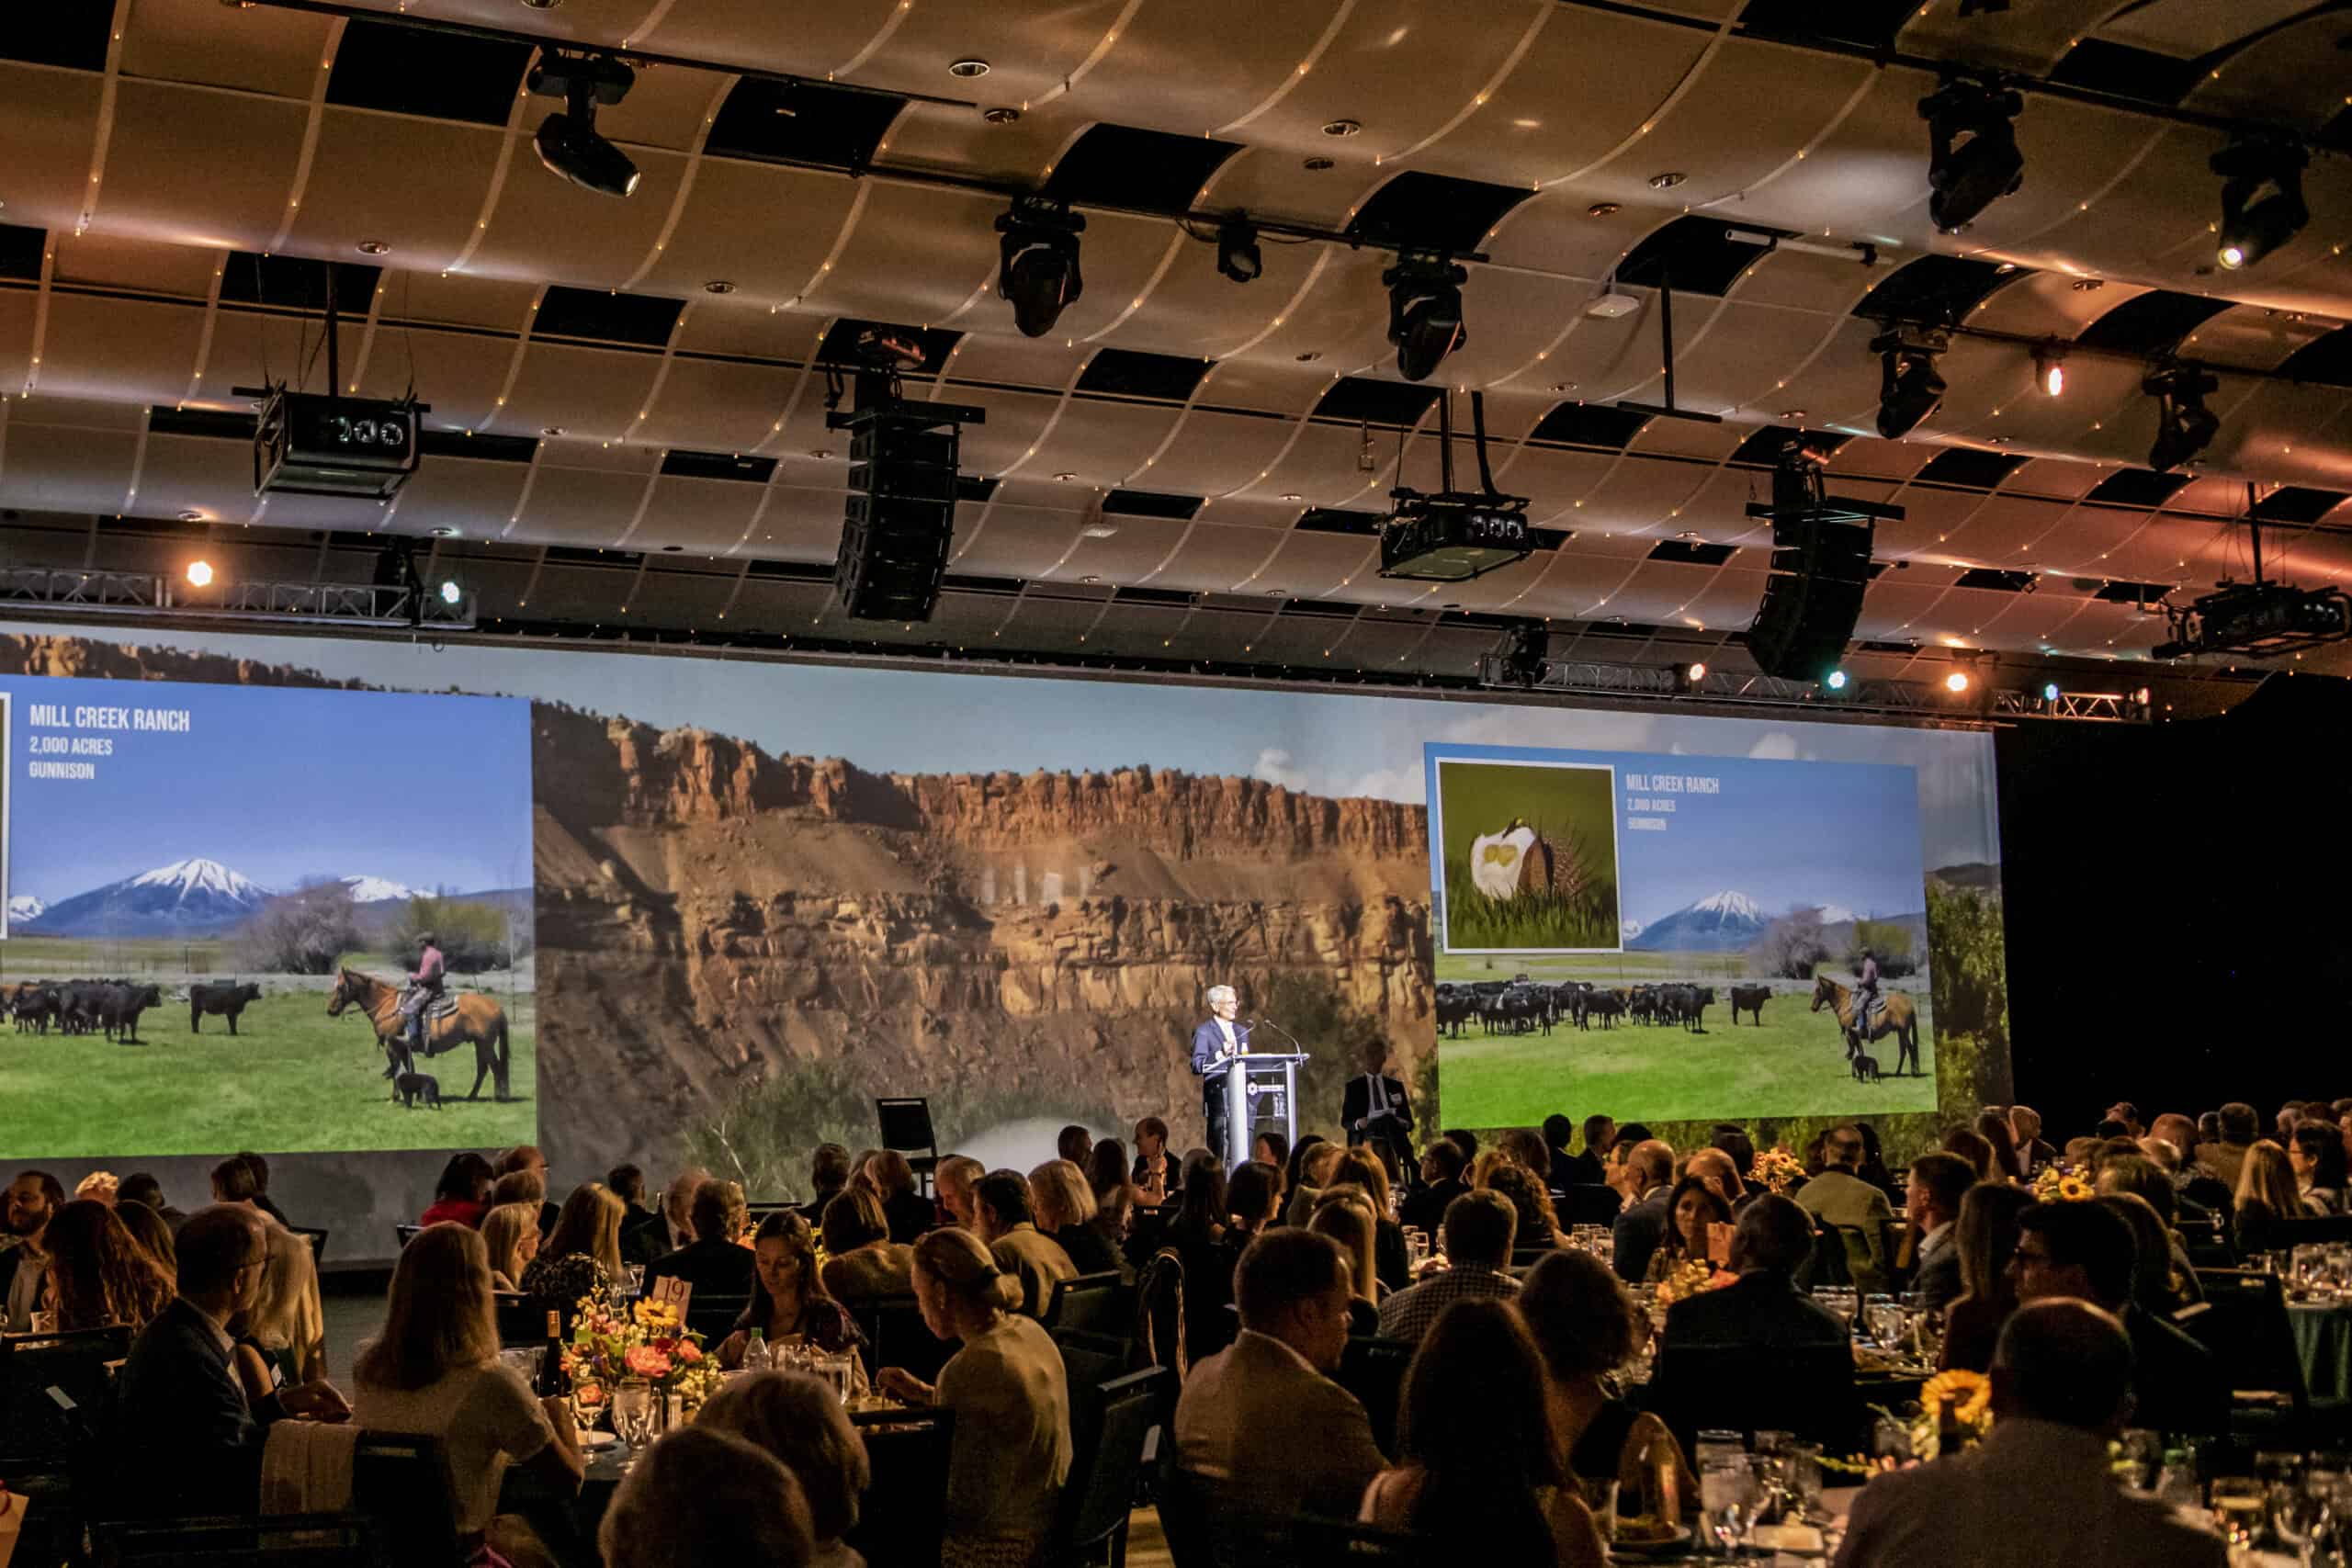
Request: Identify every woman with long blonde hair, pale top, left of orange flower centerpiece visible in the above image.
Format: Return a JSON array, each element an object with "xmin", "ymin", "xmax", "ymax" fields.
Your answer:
[{"xmin": 350, "ymin": 1223, "xmax": 585, "ymax": 1556}]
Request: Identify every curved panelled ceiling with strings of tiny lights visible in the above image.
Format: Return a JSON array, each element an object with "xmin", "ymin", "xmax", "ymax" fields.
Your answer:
[{"xmin": 0, "ymin": 0, "xmax": 2352, "ymax": 686}]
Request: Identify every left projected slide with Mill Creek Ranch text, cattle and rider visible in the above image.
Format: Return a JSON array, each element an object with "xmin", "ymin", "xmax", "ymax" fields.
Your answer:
[{"xmin": 0, "ymin": 677, "xmax": 538, "ymax": 1161}]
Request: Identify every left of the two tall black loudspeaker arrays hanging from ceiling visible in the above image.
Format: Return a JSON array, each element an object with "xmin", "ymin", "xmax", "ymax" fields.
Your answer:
[{"xmin": 832, "ymin": 413, "xmax": 959, "ymax": 621}]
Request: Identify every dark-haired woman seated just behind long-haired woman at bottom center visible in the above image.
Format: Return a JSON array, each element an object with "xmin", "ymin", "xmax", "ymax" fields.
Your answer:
[{"xmin": 1510, "ymin": 1253, "xmax": 1698, "ymax": 1514}]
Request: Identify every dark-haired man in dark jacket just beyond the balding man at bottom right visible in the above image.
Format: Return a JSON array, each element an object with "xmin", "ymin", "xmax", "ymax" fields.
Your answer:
[{"xmin": 2008, "ymin": 1203, "xmax": 2230, "ymax": 1434}]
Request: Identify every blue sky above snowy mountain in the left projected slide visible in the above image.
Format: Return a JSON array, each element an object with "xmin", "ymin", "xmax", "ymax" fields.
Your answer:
[{"xmin": 0, "ymin": 677, "xmax": 532, "ymax": 903}]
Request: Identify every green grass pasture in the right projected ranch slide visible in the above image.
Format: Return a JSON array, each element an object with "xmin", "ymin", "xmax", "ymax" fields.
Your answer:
[{"xmin": 1437, "ymin": 982, "xmax": 1936, "ymax": 1126}]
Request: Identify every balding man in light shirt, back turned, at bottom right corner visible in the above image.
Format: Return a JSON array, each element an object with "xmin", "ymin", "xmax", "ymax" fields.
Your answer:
[{"xmin": 1835, "ymin": 1297, "xmax": 2230, "ymax": 1568}]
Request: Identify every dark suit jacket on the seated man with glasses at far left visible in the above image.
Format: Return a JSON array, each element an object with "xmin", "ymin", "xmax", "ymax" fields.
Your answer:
[{"xmin": 115, "ymin": 1300, "xmax": 285, "ymax": 1517}]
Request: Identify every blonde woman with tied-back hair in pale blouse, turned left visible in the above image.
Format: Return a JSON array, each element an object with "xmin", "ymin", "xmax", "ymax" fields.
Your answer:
[{"xmin": 877, "ymin": 1229, "xmax": 1072, "ymax": 1568}]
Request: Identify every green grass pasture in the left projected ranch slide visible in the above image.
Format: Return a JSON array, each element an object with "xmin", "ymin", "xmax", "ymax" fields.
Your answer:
[{"xmin": 0, "ymin": 987, "xmax": 538, "ymax": 1161}]
